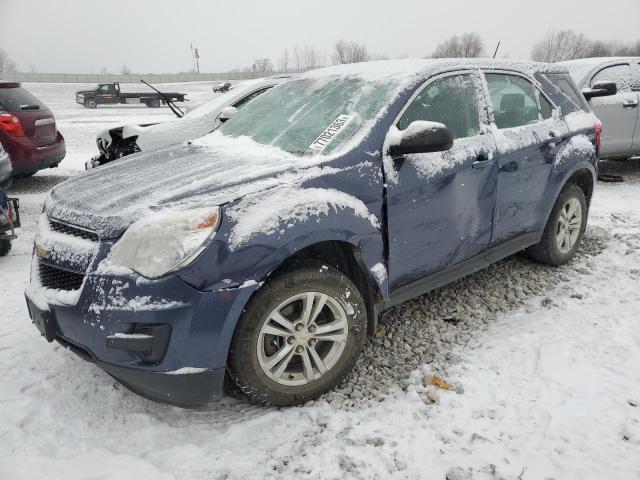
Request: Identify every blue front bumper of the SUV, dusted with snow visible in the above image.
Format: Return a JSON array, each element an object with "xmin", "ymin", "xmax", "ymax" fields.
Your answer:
[{"xmin": 26, "ymin": 251, "xmax": 260, "ymax": 407}]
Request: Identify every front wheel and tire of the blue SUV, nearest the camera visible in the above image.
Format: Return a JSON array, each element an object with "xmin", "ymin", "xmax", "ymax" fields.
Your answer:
[{"xmin": 228, "ymin": 260, "xmax": 367, "ymax": 406}]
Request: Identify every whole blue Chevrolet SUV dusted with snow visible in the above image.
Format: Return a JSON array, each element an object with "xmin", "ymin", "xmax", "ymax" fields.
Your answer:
[{"xmin": 26, "ymin": 60, "xmax": 604, "ymax": 406}]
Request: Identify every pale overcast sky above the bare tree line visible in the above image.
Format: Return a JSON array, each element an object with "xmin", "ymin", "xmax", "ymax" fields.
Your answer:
[{"xmin": 0, "ymin": 0, "xmax": 640, "ymax": 73}]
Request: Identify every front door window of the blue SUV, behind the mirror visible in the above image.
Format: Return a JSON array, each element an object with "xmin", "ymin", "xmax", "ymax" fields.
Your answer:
[{"xmin": 397, "ymin": 74, "xmax": 480, "ymax": 139}]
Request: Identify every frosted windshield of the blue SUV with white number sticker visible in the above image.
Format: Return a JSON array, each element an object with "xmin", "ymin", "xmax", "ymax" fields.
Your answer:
[{"xmin": 219, "ymin": 76, "xmax": 399, "ymax": 155}]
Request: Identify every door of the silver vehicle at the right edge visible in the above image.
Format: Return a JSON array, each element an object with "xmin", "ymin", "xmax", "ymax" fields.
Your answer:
[{"xmin": 589, "ymin": 62, "xmax": 639, "ymax": 158}]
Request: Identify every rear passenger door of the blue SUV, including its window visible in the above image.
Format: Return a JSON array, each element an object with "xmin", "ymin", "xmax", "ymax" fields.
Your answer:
[{"xmin": 485, "ymin": 72, "xmax": 569, "ymax": 245}]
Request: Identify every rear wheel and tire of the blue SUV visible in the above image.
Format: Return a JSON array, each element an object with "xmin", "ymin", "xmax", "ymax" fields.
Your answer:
[{"xmin": 527, "ymin": 183, "xmax": 588, "ymax": 266}]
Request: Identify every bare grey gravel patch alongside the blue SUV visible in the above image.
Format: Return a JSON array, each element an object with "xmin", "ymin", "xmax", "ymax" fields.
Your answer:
[{"xmin": 320, "ymin": 227, "xmax": 609, "ymax": 409}]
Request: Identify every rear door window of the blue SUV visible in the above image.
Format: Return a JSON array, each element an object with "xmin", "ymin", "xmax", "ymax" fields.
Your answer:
[{"xmin": 485, "ymin": 73, "xmax": 552, "ymax": 128}]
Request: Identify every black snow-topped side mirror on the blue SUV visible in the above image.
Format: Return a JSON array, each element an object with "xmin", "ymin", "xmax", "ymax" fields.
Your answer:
[{"xmin": 389, "ymin": 120, "xmax": 453, "ymax": 157}]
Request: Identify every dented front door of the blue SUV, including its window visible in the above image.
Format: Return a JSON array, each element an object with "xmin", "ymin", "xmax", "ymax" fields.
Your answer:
[{"xmin": 385, "ymin": 72, "xmax": 497, "ymax": 291}]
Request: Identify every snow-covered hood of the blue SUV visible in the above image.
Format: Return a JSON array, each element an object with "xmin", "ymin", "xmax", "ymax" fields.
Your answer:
[{"xmin": 45, "ymin": 132, "xmax": 326, "ymax": 238}]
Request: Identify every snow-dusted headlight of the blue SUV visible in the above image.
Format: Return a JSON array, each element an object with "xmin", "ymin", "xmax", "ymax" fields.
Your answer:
[{"xmin": 110, "ymin": 207, "xmax": 220, "ymax": 278}]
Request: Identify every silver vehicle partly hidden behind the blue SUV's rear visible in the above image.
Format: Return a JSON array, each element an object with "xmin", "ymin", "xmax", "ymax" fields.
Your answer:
[{"xmin": 560, "ymin": 57, "xmax": 640, "ymax": 158}]
